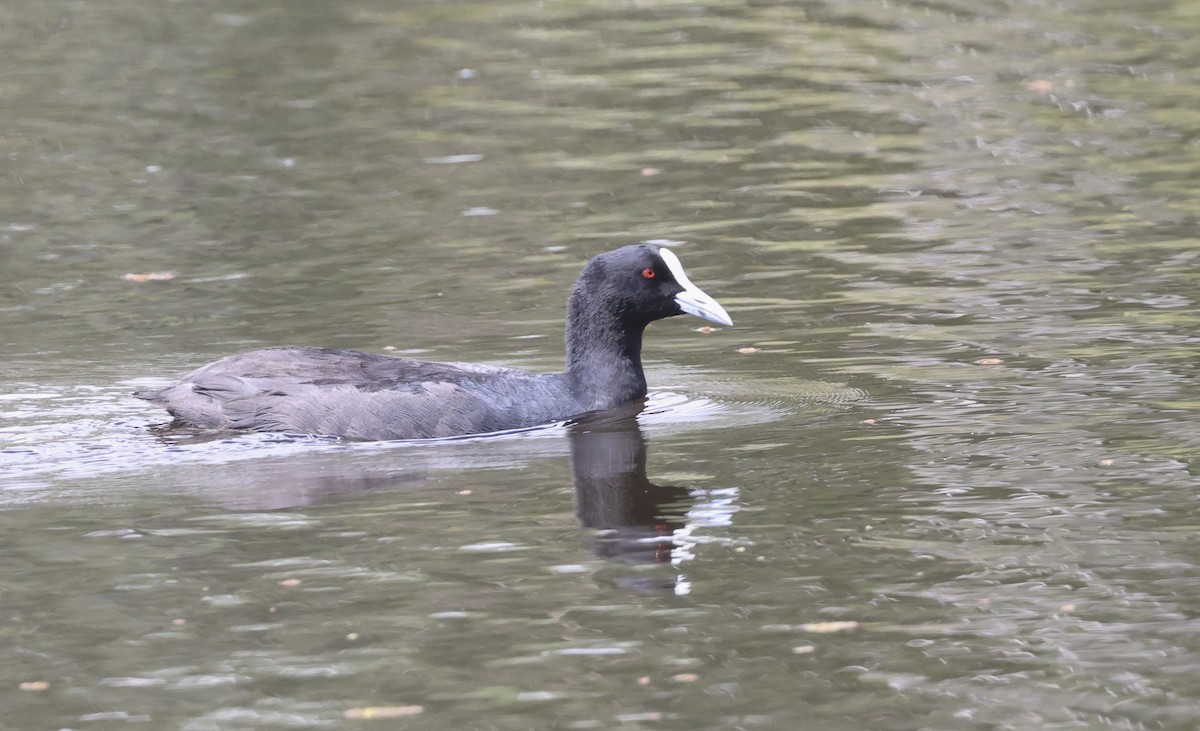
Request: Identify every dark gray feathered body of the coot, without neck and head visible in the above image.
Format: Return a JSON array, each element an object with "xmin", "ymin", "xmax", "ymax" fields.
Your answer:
[{"xmin": 136, "ymin": 347, "xmax": 592, "ymax": 439}]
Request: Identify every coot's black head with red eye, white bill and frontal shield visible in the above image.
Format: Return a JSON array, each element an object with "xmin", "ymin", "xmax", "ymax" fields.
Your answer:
[{"xmin": 571, "ymin": 245, "xmax": 733, "ymax": 326}]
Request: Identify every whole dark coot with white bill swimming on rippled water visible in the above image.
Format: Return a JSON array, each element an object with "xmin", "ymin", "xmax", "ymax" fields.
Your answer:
[{"xmin": 134, "ymin": 245, "xmax": 733, "ymax": 439}]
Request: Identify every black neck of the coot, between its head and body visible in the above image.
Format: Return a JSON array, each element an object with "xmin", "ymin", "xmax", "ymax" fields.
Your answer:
[{"xmin": 566, "ymin": 292, "xmax": 646, "ymax": 411}]
